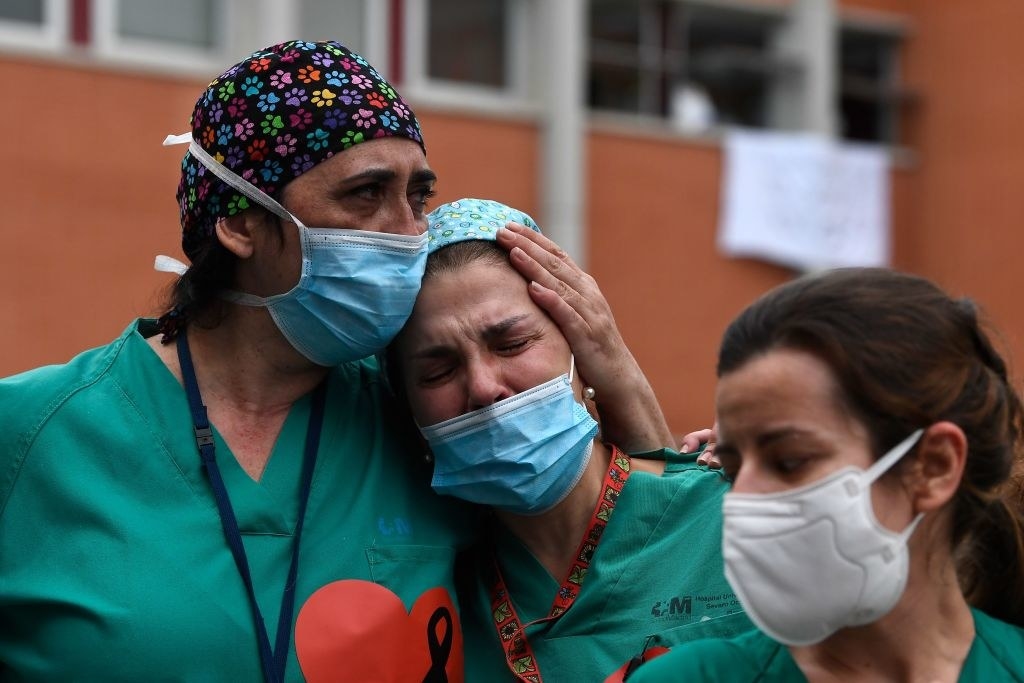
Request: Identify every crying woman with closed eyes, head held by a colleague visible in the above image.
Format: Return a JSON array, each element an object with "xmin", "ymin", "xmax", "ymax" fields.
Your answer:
[{"xmin": 388, "ymin": 199, "xmax": 751, "ymax": 683}]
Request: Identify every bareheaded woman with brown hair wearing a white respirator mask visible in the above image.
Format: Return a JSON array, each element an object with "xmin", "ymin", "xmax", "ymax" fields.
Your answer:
[{"xmin": 629, "ymin": 268, "xmax": 1024, "ymax": 683}]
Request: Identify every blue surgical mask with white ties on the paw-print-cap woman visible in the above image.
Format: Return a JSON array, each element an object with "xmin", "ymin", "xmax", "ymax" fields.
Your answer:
[{"xmin": 164, "ymin": 134, "xmax": 427, "ymax": 367}]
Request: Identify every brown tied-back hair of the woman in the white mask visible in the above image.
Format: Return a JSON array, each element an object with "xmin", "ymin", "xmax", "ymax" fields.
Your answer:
[{"xmin": 718, "ymin": 268, "xmax": 1024, "ymax": 626}]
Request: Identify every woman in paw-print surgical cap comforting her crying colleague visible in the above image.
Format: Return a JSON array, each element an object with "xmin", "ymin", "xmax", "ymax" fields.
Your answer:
[{"xmin": 0, "ymin": 41, "xmax": 664, "ymax": 683}]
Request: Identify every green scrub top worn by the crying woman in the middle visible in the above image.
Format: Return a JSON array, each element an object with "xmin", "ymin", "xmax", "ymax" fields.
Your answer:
[{"xmin": 460, "ymin": 450, "xmax": 753, "ymax": 683}]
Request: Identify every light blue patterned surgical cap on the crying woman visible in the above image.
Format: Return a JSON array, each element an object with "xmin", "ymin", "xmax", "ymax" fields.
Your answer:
[{"xmin": 427, "ymin": 199, "xmax": 541, "ymax": 253}]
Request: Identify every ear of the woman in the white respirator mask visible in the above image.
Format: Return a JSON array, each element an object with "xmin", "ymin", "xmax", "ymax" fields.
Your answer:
[{"xmin": 907, "ymin": 422, "xmax": 967, "ymax": 512}]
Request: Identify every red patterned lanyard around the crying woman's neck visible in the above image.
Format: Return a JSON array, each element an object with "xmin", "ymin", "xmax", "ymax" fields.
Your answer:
[{"xmin": 487, "ymin": 446, "xmax": 630, "ymax": 683}]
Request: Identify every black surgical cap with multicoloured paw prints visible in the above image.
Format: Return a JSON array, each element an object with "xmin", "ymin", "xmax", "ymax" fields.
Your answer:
[{"xmin": 177, "ymin": 40, "xmax": 426, "ymax": 258}]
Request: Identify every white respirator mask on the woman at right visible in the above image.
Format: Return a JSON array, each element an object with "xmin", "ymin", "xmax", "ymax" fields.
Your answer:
[{"xmin": 722, "ymin": 429, "xmax": 924, "ymax": 645}]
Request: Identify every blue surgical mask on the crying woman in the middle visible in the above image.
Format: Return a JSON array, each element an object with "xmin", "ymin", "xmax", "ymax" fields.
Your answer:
[{"xmin": 420, "ymin": 361, "xmax": 598, "ymax": 515}]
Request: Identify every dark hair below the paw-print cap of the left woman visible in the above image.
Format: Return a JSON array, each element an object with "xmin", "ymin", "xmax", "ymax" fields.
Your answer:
[{"xmin": 157, "ymin": 207, "xmax": 284, "ymax": 344}]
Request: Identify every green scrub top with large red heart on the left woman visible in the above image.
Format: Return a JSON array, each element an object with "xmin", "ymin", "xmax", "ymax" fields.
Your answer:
[{"xmin": 0, "ymin": 321, "xmax": 476, "ymax": 681}]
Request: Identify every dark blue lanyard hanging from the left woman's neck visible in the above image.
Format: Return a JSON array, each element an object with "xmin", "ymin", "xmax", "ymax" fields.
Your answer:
[{"xmin": 177, "ymin": 331, "xmax": 327, "ymax": 683}]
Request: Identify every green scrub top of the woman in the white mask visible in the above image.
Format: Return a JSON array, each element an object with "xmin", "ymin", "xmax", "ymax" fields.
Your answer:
[{"xmin": 628, "ymin": 609, "xmax": 1024, "ymax": 683}]
